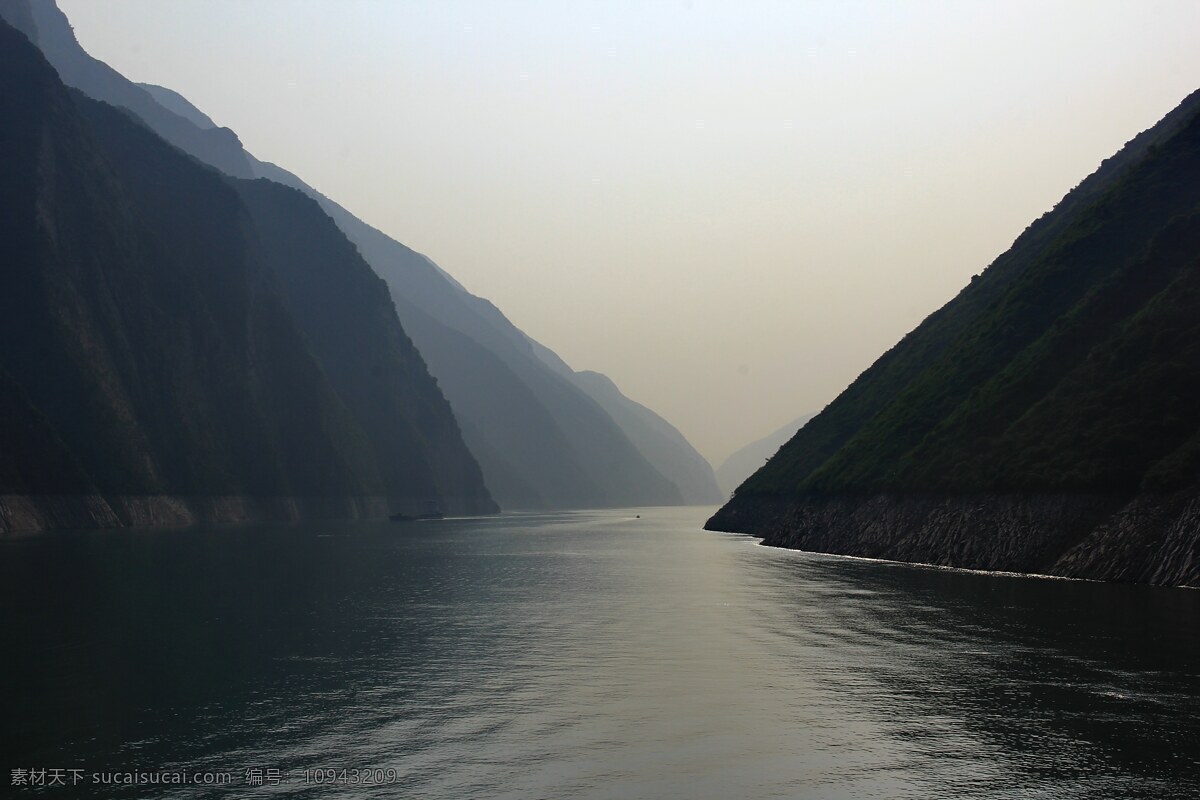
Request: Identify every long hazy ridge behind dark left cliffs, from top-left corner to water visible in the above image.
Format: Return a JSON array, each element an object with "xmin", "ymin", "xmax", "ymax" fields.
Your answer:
[{"xmin": 0, "ymin": 0, "xmax": 706, "ymax": 509}]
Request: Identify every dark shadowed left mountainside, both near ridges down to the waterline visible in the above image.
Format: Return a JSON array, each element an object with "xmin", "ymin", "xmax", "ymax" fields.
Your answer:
[{"xmin": 0, "ymin": 15, "xmax": 496, "ymax": 530}]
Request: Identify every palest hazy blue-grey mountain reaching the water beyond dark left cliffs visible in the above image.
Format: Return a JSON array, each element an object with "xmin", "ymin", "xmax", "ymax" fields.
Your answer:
[{"xmin": 252, "ymin": 146, "xmax": 691, "ymax": 509}]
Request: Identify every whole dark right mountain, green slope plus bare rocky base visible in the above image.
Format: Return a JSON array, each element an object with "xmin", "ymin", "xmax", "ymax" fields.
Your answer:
[{"xmin": 708, "ymin": 92, "xmax": 1200, "ymax": 584}]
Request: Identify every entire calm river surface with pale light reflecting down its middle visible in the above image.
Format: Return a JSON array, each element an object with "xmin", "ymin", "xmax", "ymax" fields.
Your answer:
[{"xmin": 0, "ymin": 509, "xmax": 1200, "ymax": 800}]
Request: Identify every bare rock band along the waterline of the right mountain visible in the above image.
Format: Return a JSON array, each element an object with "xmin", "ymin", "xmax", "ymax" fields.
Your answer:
[{"xmin": 704, "ymin": 491, "xmax": 1200, "ymax": 587}]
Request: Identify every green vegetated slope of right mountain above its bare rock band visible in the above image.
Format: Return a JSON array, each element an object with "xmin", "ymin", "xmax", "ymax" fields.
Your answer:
[{"xmin": 738, "ymin": 92, "xmax": 1200, "ymax": 499}]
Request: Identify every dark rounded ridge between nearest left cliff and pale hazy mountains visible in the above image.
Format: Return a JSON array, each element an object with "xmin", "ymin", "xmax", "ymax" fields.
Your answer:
[{"xmin": 233, "ymin": 179, "xmax": 497, "ymax": 513}]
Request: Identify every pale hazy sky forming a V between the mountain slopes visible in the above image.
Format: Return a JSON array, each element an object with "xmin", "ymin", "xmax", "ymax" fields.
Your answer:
[{"xmin": 59, "ymin": 0, "xmax": 1200, "ymax": 464}]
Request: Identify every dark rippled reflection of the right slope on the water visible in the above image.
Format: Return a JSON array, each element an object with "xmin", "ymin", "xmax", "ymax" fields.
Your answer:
[{"xmin": 751, "ymin": 552, "xmax": 1200, "ymax": 798}]
